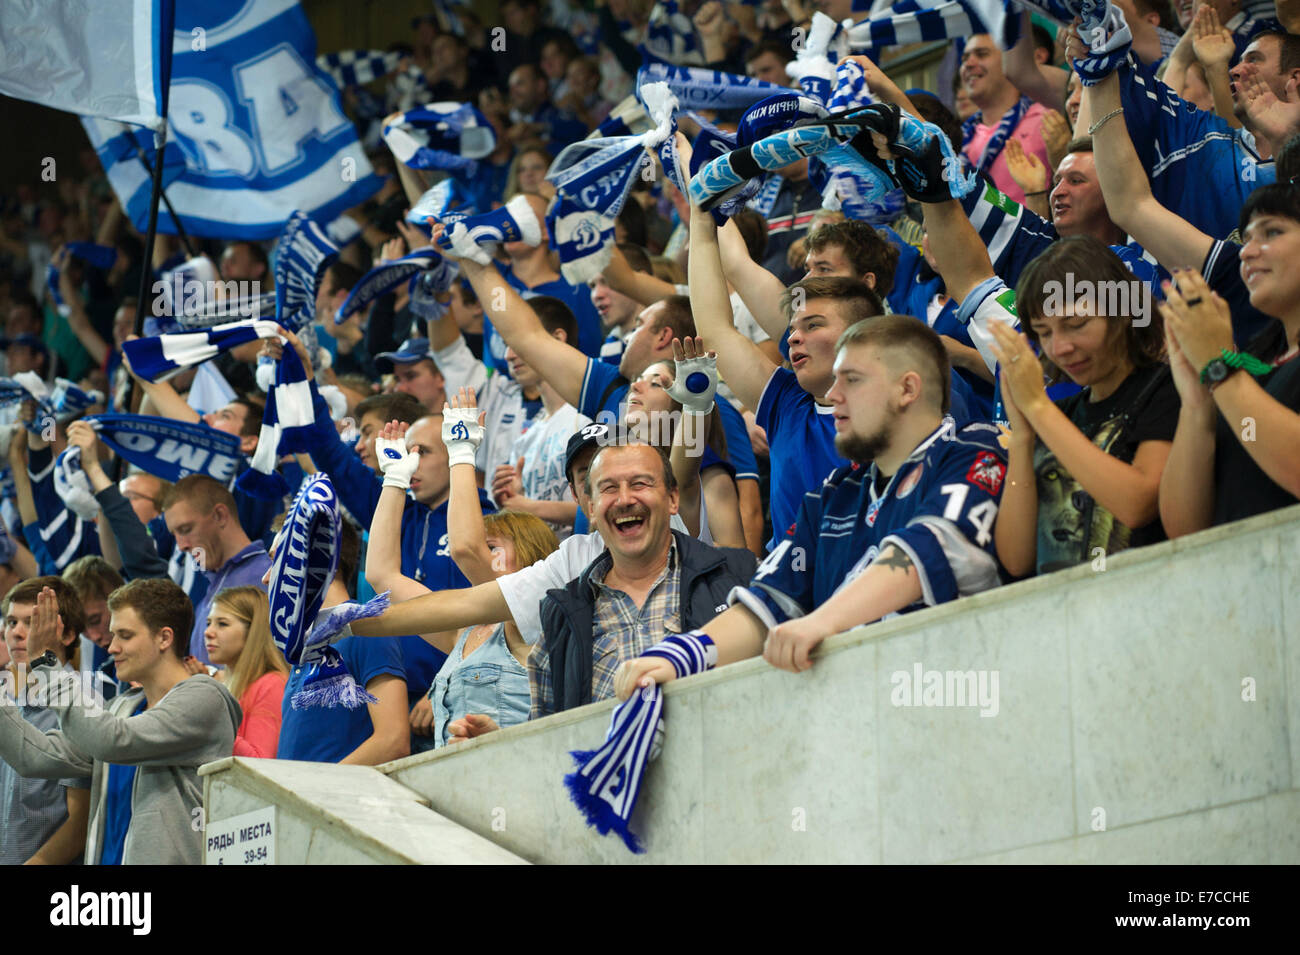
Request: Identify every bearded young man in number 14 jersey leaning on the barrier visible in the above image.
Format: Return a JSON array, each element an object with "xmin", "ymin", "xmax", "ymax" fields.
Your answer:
[{"xmin": 616, "ymin": 316, "xmax": 1006, "ymax": 699}]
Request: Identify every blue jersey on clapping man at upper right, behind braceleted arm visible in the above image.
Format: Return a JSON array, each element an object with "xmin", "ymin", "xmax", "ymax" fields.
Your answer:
[{"xmin": 1112, "ymin": 57, "xmax": 1278, "ymax": 239}]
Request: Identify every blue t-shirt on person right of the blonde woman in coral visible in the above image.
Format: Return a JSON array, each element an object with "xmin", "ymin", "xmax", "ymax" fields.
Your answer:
[{"xmin": 276, "ymin": 637, "xmax": 405, "ymax": 763}]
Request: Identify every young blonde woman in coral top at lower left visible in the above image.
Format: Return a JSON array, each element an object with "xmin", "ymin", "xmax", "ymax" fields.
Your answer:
[{"xmin": 203, "ymin": 587, "xmax": 289, "ymax": 759}]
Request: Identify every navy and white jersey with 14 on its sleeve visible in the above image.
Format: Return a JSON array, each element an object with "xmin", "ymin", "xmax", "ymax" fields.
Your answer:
[{"xmin": 731, "ymin": 420, "xmax": 1006, "ymax": 628}]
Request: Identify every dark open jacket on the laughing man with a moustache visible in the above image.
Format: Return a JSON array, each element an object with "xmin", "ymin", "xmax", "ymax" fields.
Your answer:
[{"xmin": 541, "ymin": 530, "xmax": 758, "ymax": 712}]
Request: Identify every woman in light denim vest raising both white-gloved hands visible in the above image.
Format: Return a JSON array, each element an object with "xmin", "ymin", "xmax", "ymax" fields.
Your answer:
[{"xmin": 365, "ymin": 388, "xmax": 559, "ymax": 748}]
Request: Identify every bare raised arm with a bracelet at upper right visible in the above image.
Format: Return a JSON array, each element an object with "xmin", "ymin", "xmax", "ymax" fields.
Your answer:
[{"xmin": 1083, "ymin": 73, "xmax": 1214, "ymax": 272}]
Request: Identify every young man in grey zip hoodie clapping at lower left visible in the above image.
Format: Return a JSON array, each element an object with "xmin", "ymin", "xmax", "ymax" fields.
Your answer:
[{"xmin": 0, "ymin": 579, "xmax": 242, "ymax": 865}]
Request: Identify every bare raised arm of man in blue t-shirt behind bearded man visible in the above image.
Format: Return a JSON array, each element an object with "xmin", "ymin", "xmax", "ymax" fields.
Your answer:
[{"xmin": 689, "ymin": 208, "xmax": 784, "ymax": 408}]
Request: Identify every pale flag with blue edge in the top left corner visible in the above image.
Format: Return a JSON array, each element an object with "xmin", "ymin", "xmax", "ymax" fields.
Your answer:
[{"xmin": 0, "ymin": 0, "xmax": 176, "ymax": 131}]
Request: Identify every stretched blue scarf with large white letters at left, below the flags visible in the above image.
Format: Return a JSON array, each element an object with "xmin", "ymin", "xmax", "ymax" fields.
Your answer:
[{"xmin": 86, "ymin": 413, "xmax": 243, "ymax": 485}]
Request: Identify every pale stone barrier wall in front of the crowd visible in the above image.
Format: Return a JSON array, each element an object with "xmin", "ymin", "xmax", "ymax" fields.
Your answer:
[{"xmin": 200, "ymin": 507, "xmax": 1300, "ymax": 864}]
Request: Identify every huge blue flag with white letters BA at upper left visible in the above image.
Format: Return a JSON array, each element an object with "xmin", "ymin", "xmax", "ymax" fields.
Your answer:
[{"xmin": 83, "ymin": 0, "xmax": 381, "ymax": 239}]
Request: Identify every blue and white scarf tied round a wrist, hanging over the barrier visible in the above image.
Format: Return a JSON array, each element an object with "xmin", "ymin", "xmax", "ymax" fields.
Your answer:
[{"xmin": 564, "ymin": 630, "xmax": 718, "ymax": 852}]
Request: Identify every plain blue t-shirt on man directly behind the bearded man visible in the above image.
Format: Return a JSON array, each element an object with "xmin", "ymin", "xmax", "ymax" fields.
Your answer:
[{"xmin": 754, "ymin": 368, "xmax": 849, "ymax": 550}]
